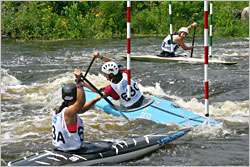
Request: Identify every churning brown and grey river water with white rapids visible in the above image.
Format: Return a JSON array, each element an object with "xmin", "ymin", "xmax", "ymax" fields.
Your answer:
[{"xmin": 1, "ymin": 37, "xmax": 249, "ymax": 166}]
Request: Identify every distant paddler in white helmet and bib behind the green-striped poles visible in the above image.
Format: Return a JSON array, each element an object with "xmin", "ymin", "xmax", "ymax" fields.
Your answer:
[{"xmin": 157, "ymin": 22, "xmax": 198, "ymax": 57}]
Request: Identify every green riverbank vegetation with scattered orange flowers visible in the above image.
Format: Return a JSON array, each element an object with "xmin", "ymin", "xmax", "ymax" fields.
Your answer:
[{"xmin": 1, "ymin": 1, "xmax": 249, "ymax": 40}]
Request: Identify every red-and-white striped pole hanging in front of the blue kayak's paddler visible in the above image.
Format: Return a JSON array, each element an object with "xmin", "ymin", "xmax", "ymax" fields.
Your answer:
[{"xmin": 127, "ymin": 1, "xmax": 131, "ymax": 99}]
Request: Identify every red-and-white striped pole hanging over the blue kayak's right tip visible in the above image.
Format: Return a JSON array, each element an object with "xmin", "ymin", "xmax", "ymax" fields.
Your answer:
[{"xmin": 204, "ymin": 1, "xmax": 209, "ymax": 117}]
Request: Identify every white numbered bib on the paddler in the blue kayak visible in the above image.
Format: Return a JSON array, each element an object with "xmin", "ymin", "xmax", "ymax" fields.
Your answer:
[{"xmin": 111, "ymin": 73, "xmax": 142, "ymax": 107}]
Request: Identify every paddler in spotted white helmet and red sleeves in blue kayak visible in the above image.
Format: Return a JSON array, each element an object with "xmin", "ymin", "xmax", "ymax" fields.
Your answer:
[{"xmin": 84, "ymin": 52, "xmax": 144, "ymax": 109}]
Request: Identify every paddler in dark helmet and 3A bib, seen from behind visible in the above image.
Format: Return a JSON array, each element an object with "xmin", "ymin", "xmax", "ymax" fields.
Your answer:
[{"xmin": 52, "ymin": 69, "xmax": 101, "ymax": 151}]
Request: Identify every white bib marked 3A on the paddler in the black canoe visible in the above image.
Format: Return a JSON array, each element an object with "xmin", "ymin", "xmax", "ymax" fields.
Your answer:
[{"xmin": 52, "ymin": 107, "xmax": 84, "ymax": 151}]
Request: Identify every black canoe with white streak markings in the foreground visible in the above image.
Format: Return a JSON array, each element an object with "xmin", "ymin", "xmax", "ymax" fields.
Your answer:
[{"xmin": 8, "ymin": 128, "xmax": 191, "ymax": 166}]
